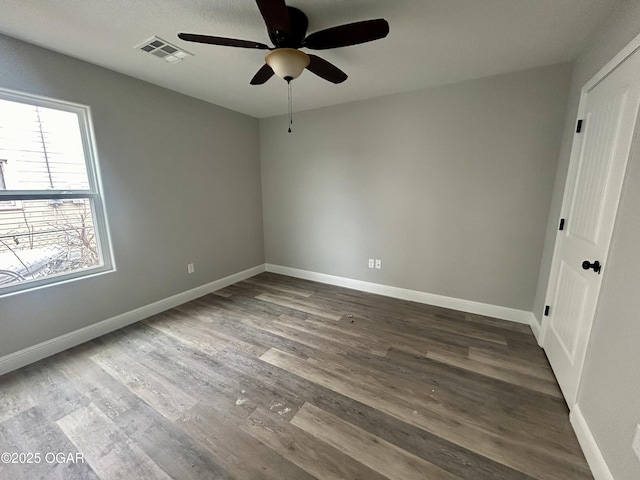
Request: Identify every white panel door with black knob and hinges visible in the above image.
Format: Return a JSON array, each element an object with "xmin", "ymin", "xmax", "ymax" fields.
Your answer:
[{"xmin": 542, "ymin": 47, "xmax": 640, "ymax": 407}]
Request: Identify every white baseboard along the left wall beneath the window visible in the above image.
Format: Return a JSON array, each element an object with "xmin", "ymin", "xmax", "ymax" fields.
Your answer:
[{"xmin": 0, "ymin": 264, "xmax": 264, "ymax": 375}]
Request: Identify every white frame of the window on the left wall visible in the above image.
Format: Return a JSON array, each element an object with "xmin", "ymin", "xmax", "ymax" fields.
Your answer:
[{"xmin": 0, "ymin": 88, "xmax": 115, "ymax": 298}]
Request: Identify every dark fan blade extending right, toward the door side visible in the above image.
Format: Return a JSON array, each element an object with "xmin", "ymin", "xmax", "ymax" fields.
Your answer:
[{"xmin": 302, "ymin": 18, "xmax": 389, "ymax": 50}]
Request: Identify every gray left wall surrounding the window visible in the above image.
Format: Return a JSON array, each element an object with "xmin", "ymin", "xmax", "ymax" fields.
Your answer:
[{"xmin": 0, "ymin": 36, "xmax": 264, "ymax": 357}]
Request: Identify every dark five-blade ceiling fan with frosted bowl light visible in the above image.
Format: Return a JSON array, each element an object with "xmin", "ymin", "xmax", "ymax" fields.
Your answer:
[{"xmin": 178, "ymin": 0, "xmax": 389, "ymax": 85}]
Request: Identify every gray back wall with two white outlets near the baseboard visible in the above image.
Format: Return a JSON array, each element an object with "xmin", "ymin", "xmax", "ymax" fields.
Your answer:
[{"xmin": 260, "ymin": 64, "xmax": 571, "ymax": 311}]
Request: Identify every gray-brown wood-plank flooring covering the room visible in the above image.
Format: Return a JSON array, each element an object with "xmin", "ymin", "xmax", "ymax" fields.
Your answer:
[{"xmin": 0, "ymin": 273, "xmax": 593, "ymax": 480}]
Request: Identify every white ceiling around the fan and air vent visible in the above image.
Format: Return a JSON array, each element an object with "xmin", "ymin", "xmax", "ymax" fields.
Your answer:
[{"xmin": 0, "ymin": 0, "xmax": 621, "ymax": 118}]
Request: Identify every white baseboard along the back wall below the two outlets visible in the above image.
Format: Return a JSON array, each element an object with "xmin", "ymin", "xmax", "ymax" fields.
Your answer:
[{"xmin": 265, "ymin": 263, "xmax": 535, "ymax": 325}]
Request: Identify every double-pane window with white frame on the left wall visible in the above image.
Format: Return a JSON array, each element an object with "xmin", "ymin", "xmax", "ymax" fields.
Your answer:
[{"xmin": 0, "ymin": 90, "xmax": 112, "ymax": 295}]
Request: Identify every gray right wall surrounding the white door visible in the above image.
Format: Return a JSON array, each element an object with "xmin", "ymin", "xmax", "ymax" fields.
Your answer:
[{"xmin": 535, "ymin": 1, "xmax": 640, "ymax": 480}]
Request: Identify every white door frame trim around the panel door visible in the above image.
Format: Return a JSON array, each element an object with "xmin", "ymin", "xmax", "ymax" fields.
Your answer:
[{"xmin": 539, "ymin": 34, "xmax": 640, "ymax": 409}]
